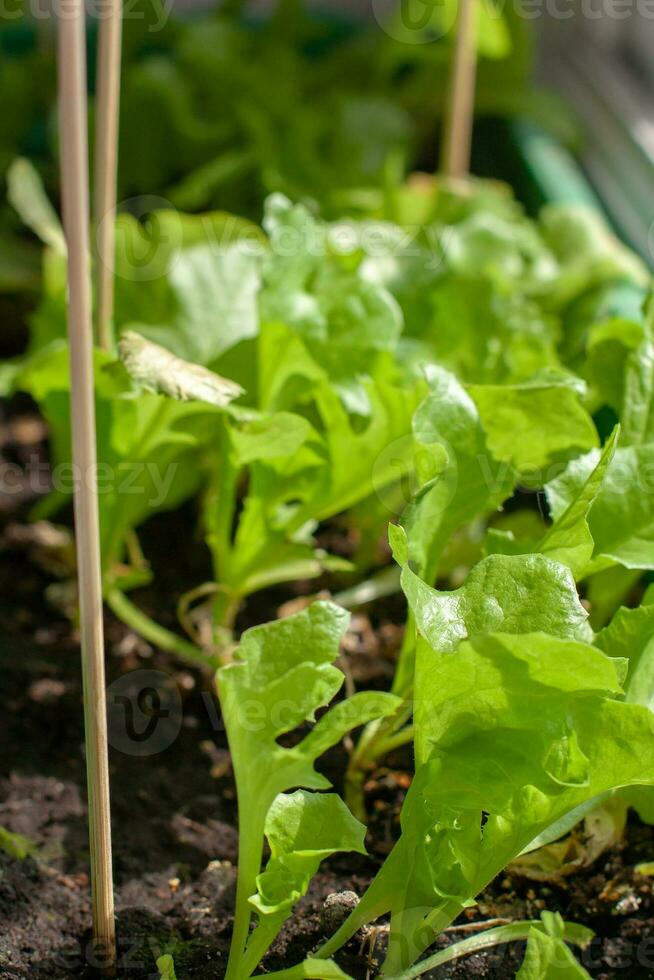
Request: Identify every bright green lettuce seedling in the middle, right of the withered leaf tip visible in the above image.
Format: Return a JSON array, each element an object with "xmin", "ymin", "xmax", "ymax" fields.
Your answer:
[{"xmin": 204, "ymin": 327, "xmax": 424, "ymax": 626}]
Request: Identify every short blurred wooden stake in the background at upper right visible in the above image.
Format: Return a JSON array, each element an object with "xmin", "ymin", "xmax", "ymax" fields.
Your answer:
[{"xmin": 441, "ymin": 0, "xmax": 477, "ymax": 177}]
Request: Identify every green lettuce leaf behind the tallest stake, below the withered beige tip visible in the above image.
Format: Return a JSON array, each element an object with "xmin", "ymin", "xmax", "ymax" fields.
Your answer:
[{"xmin": 14, "ymin": 341, "xmax": 220, "ymax": 579}]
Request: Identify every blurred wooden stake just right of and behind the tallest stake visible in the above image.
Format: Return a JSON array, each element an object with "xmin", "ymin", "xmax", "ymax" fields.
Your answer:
[{"xmin": 93, "ymin": 0, "xmax": 123, "ymax": 350}]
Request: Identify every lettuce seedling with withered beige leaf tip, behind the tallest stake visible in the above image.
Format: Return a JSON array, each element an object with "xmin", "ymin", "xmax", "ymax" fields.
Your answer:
[{"xmin": 13, "ymin": 338, "xmax": 240, "ymax": 665}]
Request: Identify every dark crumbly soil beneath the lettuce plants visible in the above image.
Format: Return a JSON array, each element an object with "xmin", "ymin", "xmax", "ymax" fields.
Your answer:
[{"xmin": 0, "ymin": 405, "xmax": 654, "ymax": 980}]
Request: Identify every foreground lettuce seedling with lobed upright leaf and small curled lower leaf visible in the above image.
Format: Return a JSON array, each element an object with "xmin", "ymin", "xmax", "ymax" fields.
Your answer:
[{"xmin": 217, "ymin": 602, "xmax": 400, "ymax": 980}]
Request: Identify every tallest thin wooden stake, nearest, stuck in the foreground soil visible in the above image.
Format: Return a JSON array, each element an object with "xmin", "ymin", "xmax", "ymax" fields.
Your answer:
[{"xmin": 59, "ymin": 0, "xmax": 116, "ymax": 972}]
